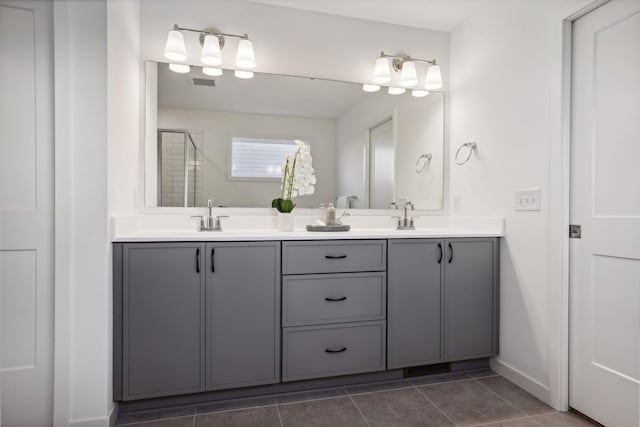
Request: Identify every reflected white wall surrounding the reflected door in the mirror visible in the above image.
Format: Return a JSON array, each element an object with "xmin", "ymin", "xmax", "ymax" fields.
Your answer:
[{"xmin": 336, "ymin": 92, "xmax": 444, "ymax": 209}]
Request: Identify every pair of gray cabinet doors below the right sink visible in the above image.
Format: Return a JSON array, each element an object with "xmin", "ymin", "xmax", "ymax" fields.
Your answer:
[{"xmin": 387, "ymin": 238, "xmax": 499, "ymax": 369}]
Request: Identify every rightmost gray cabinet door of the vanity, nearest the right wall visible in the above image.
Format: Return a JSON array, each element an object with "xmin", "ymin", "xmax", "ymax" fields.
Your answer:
[{"xmin": 444, "ymin": 238, "xmax": 498, "ymax": 361}]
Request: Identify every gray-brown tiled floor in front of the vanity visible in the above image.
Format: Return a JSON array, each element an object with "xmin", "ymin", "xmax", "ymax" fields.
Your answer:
[{"xmin": 117, "ymin": 371, "xmax": 593, "ymax": 427}]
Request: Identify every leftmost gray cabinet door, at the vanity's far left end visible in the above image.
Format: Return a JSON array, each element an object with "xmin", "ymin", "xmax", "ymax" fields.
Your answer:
[{"xmin": 122, "ymin": 243, "xmax": 205, "ymax": 400}]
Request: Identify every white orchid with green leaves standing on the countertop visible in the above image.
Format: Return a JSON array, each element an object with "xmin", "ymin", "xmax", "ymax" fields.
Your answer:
[{"xmin": 271, "ymin": 139, "xmax": 316, "ymax": 213}]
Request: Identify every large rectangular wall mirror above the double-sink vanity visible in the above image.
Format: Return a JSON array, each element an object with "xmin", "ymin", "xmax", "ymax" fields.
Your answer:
[{"xmin": 145, "ymin": 62, "xmax": 444, "ymax": 209}]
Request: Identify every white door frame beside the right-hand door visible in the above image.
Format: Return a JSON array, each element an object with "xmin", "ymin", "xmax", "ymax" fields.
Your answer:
[{"xmin": 560, "ymin": 0, "xmax": 610, "ymax": 411}]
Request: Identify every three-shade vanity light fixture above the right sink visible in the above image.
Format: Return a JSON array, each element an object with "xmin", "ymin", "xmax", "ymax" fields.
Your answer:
[{"xmin": 362, "ymin": 52, "xmax": 442, "ymax": 98}]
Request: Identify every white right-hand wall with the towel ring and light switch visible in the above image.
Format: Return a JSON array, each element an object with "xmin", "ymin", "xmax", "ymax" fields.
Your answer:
[{"xmin": 450, "ymin": 0, "xmax": 589, "ymax": 408}]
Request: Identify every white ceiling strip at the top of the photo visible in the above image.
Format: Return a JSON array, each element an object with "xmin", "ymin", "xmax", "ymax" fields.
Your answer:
[{"xmin": 250, "ymin": 0, "xmax": 495, "ymax": 32}]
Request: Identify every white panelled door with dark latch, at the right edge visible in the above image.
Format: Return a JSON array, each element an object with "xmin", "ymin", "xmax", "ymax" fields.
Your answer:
[{"xmin": 569, "ymin": 0, "xmax": 640, "ymax": 427}]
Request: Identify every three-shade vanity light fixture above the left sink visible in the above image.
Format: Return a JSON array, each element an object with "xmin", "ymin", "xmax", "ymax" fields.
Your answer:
[{"xmin": 164, "ymin": 24, "xmax": 256, "ymax": 79}]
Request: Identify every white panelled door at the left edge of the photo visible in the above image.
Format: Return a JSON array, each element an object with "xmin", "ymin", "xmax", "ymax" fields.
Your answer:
[{"xmin": 0, "ymin": 0, "xmax": 53, "ymax": 427}]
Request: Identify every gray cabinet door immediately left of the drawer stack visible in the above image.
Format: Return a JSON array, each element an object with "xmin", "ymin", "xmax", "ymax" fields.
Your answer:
[{"xmin": 206, "ymin": 242, "xmax": 280, "ymax": 390}]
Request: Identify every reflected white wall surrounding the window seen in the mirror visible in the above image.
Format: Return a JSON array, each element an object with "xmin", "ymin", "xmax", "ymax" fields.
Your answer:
[{"xmin": 158, "ymin": 108, "xmax": 336, "ymax": 208}]
